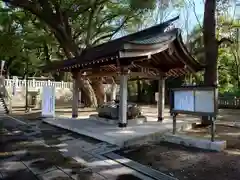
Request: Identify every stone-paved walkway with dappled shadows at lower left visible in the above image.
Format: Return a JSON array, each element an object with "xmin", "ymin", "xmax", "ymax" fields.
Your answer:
[{"xmin": 0, "ymin": 117, "xmax": 174, "ymax": 180}]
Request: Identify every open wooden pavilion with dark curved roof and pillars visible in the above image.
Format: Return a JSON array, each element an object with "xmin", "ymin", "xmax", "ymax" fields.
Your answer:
[{"xmin": 45, "ymin": 17, "xmax": 204, "ymax": 127}]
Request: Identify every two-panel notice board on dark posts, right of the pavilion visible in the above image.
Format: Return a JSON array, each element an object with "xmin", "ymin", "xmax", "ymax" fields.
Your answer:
[{"xmin": 170, "ymin": 86, "xmax": 218, "ymax": 141}]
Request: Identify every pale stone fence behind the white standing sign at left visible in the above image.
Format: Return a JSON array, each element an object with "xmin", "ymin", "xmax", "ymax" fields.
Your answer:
[{"xmin": 4, "ymin": 79, "xmax": 119, "ymax": 107}]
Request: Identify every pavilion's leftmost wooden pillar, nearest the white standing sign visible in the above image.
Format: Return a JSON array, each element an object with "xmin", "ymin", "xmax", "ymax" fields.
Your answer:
[{"xmin": 72, "ymin": 73, "xmax": 79, "ymax": 118}]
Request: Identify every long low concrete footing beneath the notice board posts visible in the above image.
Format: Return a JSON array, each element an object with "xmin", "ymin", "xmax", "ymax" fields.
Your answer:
[{"xmin": 162, "ymin": 133, "xmax": 227, "ymax": 151}]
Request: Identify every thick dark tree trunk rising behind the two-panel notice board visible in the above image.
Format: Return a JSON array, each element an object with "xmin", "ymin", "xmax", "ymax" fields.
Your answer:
[{"xmin": 202, "ymin": 0, "xmax": 218, "ymax": 125}]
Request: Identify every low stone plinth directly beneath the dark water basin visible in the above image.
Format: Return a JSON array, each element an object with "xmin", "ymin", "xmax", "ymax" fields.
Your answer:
[{"xmin": 89, "ymin": 114, "xmax": 147, "ymax": 125}]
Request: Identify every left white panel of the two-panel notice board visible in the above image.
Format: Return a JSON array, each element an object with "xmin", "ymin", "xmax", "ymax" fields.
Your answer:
[{"xmin": 174, "ymin": 90, "xmax": 194, "ymax": 111}]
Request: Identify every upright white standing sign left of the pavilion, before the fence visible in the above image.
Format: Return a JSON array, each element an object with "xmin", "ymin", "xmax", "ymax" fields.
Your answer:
[{"xmin": 42, "ymin": 86, "xmax": 55, "ymax": 117}]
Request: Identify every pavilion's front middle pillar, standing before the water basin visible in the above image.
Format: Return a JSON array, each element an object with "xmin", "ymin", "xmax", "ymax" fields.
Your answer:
[{"xmin": 119, "ymin": 68, "xmax": 128, "ymax": 128}]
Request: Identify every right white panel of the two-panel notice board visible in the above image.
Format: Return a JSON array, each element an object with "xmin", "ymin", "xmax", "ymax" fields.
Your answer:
[{"xmin": 195, "ymin": 90, "xmax": 214, "ymax": 113}]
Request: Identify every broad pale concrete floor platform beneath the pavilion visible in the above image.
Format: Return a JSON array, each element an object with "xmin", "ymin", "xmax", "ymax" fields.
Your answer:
[{"xmin": 43, "ymin": 118, "xmax": 192, "ymax": 148}]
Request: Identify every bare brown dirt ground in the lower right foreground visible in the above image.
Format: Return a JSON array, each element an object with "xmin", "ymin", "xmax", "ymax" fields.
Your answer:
[{"xmin": 121, "ymin": 143, "xmax": 240, "ymax": 180}]
